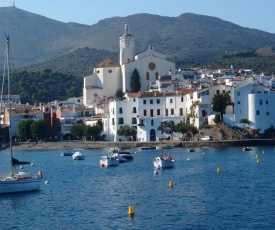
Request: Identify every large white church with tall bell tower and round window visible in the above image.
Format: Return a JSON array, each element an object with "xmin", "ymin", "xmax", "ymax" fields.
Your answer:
[{"xmin": 83, "ymin": 25, "xmax": 175, "ymax": 107}]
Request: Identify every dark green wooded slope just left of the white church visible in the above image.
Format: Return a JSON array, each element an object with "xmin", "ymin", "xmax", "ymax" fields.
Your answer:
[{"xmin": 11, "ymin": 69, "xmax": 83, "ymax": 104}]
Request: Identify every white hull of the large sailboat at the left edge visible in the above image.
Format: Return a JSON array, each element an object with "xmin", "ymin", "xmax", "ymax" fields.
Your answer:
[{"xmin": 0, "ymin": 179, "xmax": 41, "ymax": 194}]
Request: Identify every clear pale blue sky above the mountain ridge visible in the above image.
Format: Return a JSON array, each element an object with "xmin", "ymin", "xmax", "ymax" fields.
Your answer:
[{"xmin": 0, "ymin": 0, "xmax": 275, "ymax": 33}]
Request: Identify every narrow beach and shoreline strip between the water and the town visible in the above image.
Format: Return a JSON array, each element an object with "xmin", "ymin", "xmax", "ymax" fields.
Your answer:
[{"xmin": 6, "ymin": 139, "xmax": 275, "ymax": 151}]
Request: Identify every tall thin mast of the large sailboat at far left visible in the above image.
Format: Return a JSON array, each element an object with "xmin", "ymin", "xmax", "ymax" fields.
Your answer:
[{"xmin": 6, "ymin": 36, "xmax": 13, "ymax": 175}]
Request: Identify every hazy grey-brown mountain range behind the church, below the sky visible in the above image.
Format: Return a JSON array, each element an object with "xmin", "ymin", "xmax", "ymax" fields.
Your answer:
[{"xmin": 0, "ymin": 6, "xmax": 275, "ymax": 67}]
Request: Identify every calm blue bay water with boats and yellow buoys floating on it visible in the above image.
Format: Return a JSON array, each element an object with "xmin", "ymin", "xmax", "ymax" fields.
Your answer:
[{"xmin": 0, "ymin": 147, "xmax": 275, "ymax": 229}]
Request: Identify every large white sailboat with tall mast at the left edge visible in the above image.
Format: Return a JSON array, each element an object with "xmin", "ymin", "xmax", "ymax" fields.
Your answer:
[{"xmin": 0, "ymin": 36, "xmax": 42, "ymax": 194}]
